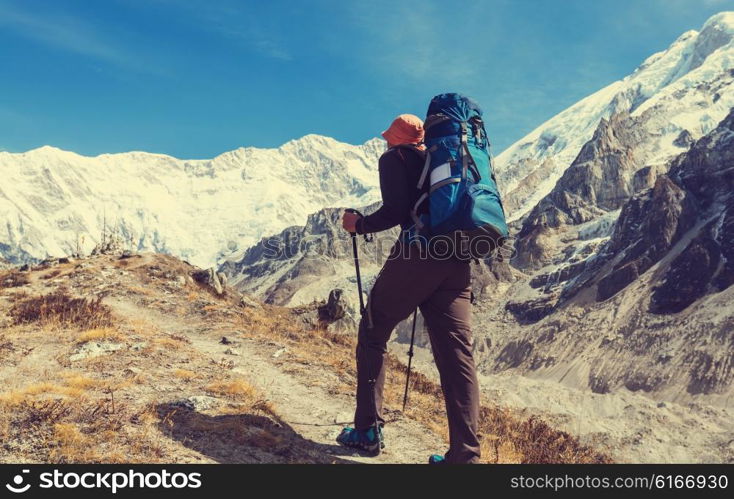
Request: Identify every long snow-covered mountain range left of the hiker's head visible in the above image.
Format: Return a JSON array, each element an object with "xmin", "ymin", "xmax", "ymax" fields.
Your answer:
[{"xmin": 0, "ymin": 135, "xmax": 385, "ymax": 266}]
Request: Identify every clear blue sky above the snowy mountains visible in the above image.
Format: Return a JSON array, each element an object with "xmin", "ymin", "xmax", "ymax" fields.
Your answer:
[{"xmin": 0, "ymin": 0, "xmax": 734, "ymax": 158}]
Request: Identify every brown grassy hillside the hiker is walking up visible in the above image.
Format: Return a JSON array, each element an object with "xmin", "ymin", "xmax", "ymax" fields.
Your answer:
[{"xmin": 0, "ymin": 254, "xmax": 608, "ymax": 463}]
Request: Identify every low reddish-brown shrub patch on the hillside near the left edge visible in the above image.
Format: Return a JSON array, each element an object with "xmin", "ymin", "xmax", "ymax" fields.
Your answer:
[{"xmin": 9, "ymin": 291, "xmax": 113, "ymax": 329}]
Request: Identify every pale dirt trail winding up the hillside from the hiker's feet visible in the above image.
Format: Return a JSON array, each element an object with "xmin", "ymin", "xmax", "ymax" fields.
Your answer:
[{"xmin": 106, "ymin": 298, "xmax": 444, "ymax": 464}]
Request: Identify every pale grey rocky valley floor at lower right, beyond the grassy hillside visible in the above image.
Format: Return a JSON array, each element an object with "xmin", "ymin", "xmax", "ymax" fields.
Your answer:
[{"xmin": 391, "ymin": 343, "xmax": 734, "ymax": 463}]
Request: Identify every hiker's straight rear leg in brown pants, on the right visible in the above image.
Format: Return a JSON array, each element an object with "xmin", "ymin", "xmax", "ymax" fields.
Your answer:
[{"xmin": 421, "ymin": 261, "xmax": 480, "ymax": 463}]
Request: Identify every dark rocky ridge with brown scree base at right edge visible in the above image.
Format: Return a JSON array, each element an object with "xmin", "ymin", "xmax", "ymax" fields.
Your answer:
[{"xmin": 479, "ymin": 111, "xmax": 734, "ymax": 407}]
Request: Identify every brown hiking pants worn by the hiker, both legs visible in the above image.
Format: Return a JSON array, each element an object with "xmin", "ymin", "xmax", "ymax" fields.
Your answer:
[{"xmin": 354, "ymin": 242, "xmax": 479, "ymax": 463}]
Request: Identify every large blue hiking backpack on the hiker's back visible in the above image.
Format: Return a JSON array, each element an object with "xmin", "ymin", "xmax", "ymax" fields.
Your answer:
[{"xmin": 411, "ymin": 94, "xmax": 508, "ymax": 258}]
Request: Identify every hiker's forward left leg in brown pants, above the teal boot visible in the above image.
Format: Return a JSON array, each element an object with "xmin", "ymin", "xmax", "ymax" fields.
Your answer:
[{"xmin": 354, "ymin": 242, "xmax": 441, "ymax": 430}]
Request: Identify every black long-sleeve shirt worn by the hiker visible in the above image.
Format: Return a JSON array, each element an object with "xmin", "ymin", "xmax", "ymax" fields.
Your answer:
[{"xmin": 356, "ymin": 147, "xmax": 425, "ymax": 234}]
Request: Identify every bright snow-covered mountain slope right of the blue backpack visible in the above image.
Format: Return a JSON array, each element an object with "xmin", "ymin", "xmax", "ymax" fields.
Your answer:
[{"xmin": 495, "ymin": 12, "xmax": 734, "ymax": 220}]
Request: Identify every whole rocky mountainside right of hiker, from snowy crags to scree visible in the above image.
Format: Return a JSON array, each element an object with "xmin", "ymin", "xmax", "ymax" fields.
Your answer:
[{"xmin": 477, "ymin": 13, "xmax": 734, "ymax": 407}]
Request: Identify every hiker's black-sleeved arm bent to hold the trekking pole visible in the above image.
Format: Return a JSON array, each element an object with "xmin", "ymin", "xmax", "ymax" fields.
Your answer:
[{"xmin": 356, "ymin": 150, "xmax": 411, "ymax": 234}]
